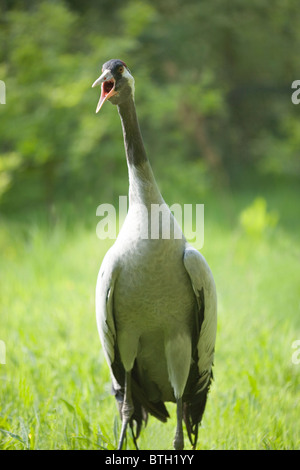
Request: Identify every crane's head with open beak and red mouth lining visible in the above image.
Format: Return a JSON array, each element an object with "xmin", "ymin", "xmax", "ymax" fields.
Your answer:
[{"xmin": 92, "ymin": 59, "xmax": 134, "ymax": 113}]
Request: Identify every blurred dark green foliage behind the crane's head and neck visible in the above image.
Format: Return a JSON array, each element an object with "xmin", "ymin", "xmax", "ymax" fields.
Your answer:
[{"xmin": 0, "ymin": 0, "xmax": 300, "ymax": 216}]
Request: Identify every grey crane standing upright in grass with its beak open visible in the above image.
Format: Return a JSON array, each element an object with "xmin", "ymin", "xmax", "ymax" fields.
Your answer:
[{"xmin": 92, "ymin": 59, "xmax": 217, "ymax": 450}]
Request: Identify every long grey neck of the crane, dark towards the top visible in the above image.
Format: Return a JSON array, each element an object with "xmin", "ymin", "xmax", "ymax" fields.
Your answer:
[{"xmin": 118, "ymin": 97, "xmax": 163, "ymax": 206}]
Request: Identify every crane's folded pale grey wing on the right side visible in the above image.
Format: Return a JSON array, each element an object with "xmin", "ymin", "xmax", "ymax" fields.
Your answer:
[{"xmin": 183, "ymin": 244, "xmax": 217, "ymax": 391}]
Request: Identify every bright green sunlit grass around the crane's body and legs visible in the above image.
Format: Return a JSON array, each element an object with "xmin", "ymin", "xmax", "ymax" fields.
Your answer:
[{"xmin": 0, "ymin": 186, "xmax": 300, "ymax": 450}]
